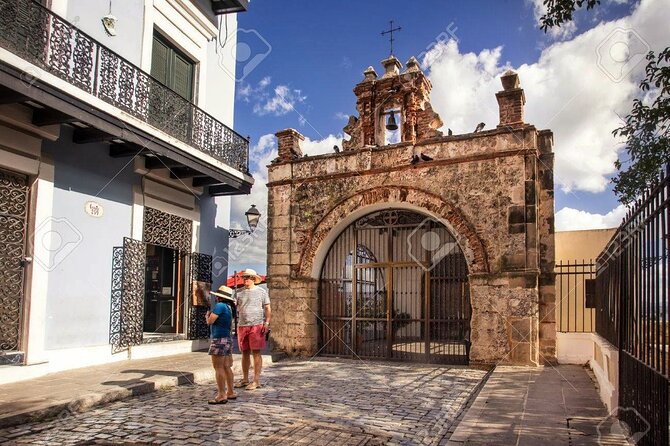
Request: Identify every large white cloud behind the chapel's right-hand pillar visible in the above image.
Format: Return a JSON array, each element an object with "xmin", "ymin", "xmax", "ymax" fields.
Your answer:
[{"xmin": 423, "ymin": 0, "xmax": 670, "ymax": 193}]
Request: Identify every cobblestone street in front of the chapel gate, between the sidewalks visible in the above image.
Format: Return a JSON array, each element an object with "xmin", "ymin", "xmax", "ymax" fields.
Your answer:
[{"xmin": 0, "ymin": 359, "xmax": 494, "ymax": 445}]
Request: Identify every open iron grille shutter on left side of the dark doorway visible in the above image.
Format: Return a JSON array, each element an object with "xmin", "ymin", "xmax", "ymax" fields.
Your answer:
[{"xmin": 109, "ymin": 237, "xmax": 146, "ymax": 353}]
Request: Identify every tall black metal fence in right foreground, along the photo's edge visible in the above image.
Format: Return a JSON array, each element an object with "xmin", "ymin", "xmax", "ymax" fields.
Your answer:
[{"xmin": 596, "ymin": 165, "xmax": 670, "ymax": 445}]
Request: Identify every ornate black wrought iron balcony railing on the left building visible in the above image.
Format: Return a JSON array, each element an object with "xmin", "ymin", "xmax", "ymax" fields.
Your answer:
[{"xmin": 0, "ymin": 0, "xmax": 249, "ymax": 173}]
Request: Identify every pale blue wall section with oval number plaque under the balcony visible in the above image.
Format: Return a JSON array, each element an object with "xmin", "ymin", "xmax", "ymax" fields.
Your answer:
[{"xmin": 38, "ymin": 127, "xmax": 139, "ymax": 349}]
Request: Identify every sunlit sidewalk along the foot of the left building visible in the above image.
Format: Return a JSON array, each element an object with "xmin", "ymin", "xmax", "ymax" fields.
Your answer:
[{"xmin": 0, "ymin": 352, "xmax": 272, "ymax": 427}]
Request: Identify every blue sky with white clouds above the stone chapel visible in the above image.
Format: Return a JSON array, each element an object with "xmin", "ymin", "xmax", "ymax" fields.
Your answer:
[{"xmin": 227, "ymin": 0, "xmax": 670, "ymax": 272}]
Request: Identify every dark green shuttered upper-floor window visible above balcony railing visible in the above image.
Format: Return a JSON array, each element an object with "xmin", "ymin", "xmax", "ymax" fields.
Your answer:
[{"xmin": 151, "ymin": 34, "xmax": 195, "ymax": 101}]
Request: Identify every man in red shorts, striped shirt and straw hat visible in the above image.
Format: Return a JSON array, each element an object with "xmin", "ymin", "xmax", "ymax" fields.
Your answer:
[{"xmin": 235, "ymin": 269, "xmax": 271, "ymax": 390}]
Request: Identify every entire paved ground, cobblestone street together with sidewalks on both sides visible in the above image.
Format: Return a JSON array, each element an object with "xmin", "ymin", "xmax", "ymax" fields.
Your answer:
[{"xmin": 0, "ymin": 352, "xmax": 625, "ymax": 446}]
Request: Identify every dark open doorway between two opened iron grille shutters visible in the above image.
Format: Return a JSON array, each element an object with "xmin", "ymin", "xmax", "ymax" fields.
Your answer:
[{"xmin": 144, "ymin": 244, "xmax": 184, "ymax": 333}]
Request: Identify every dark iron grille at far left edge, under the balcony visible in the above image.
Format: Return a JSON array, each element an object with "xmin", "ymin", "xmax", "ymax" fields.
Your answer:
[{"xmin": 0, "ymin": 169, "xmax": 28, "ymax": 351}]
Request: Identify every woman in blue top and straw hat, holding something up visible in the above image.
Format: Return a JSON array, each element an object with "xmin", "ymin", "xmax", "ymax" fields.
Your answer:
[{"xmin": 206, "ymin": 285, "xmax": 237, "ymax": 404}]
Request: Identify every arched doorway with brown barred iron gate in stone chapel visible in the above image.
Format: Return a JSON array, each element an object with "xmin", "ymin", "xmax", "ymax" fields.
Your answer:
[{"xmin": 319, "ymin": 209, "xmax": 471, "ymax": 364}]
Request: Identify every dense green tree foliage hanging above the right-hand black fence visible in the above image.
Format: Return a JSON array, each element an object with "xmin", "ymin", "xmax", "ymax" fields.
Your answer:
[{"xmin": 612, "ymin": 48, "xmax": 670, "ymax": 204}]
